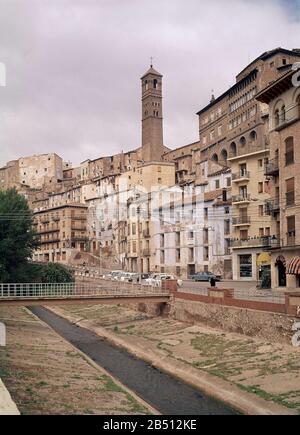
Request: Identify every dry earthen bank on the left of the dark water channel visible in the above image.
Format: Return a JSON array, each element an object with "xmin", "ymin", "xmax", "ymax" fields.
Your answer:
[{"xmin": 0, "ymin": 308, "xmax": 150, "ymax": 415}]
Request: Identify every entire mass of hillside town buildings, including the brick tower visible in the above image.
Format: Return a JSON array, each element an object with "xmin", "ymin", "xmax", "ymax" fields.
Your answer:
[{"xmin": 0, "ymin": 48, "xmax": 300, "ymax": 288}]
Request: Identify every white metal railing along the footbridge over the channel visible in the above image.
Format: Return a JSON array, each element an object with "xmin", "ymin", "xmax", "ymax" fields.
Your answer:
[{"xmin": 0, "ymin": 281, "xmax": 169, "ymax": 300}]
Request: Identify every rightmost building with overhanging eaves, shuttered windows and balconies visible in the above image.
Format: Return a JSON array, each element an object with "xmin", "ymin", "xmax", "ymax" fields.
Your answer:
[{"xmin": 257, "ymin": 70, "xmax": 300, "ymax": 289}]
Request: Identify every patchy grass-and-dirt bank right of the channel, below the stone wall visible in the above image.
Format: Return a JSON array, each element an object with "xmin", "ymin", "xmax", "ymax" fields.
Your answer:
[{"xmin": 56, "ymin": 305, "xmax": 300, "ymax": 414}]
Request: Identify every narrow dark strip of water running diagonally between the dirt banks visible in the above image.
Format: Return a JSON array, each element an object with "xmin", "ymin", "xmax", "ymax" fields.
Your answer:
[{"xmin": 29, "ymin": 307, "xmax": 238, "ymax": 415}]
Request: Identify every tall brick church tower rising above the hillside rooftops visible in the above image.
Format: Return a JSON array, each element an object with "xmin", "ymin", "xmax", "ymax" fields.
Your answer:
[{"xmin": 141, "ymin": 65, "xmax": 164, "ymax": 162}]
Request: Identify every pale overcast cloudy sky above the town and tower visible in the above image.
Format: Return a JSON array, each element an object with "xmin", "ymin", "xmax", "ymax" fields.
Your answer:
[{"xmin": 0, "ymin": 0, "xmax": 300, "ymax": 165}]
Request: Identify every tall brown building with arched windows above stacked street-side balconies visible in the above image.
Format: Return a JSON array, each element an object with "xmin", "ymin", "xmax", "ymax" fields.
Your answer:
[{"xmin": 196, "ymin": 48, "xmax": 300, "ymax": 280}]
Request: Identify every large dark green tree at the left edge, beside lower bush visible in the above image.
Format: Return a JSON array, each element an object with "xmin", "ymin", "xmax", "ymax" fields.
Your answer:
[{"xmin": 0, "ymin": 189, "xmax": 39, "ymax": 282}]
